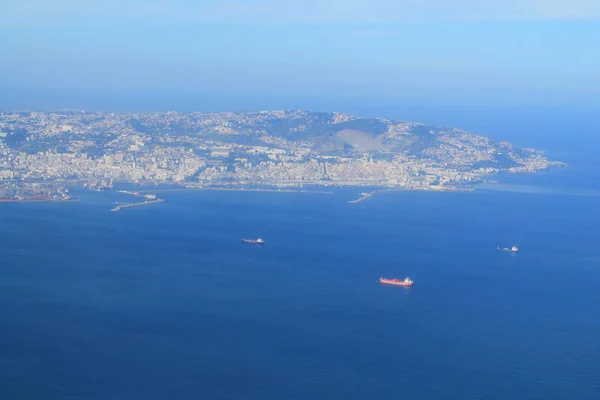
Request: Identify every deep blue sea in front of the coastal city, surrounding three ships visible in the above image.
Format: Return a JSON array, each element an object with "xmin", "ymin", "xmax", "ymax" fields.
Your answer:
[{"xmin": 0, "ymin": 189, "xmax": 600, "ymax": 400}]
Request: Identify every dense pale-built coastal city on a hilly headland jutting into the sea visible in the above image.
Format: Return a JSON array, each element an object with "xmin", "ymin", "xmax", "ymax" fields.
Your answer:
[{"xmin": 0, "ymin": 110, "xmax": 562, "ymax": 199}]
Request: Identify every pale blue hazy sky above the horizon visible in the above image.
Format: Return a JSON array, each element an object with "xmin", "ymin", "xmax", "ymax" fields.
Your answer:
[{"xmin": 0, "ymin": 0, "xmax": 600, "ymax": 109}]
